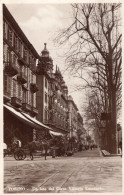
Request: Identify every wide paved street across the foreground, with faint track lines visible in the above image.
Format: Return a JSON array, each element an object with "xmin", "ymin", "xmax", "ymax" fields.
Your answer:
[{"xmin": 4, "ymin": 149, "xmax": 122, "ymax": 193}]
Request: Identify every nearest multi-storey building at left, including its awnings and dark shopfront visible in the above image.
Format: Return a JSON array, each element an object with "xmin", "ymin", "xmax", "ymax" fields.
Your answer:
[{"xmin": 3, "ymin": 5, "xmax": 51, "ymax": 144}]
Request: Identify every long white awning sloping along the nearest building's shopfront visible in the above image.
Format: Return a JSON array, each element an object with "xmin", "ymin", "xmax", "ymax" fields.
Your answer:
[{"xmin": 4, "ymin": 104, "xmax": 51, "ymax": 130}]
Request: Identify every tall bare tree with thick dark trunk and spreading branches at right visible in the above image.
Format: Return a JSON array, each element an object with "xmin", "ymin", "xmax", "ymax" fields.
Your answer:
[{"xmin": 56, "ymin": 4, "xmax": 122, "ymax": 153}]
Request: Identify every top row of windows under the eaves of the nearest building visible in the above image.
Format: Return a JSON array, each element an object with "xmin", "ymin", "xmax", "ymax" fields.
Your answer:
[{"xmin": 3, "ymin": 20, "xmax": 36, "ymax": 65}]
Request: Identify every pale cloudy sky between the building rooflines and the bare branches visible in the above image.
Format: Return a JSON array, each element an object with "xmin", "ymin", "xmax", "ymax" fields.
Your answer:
[{"xmin": 6, "ymin": 3, "xmax": 85, "ymax": 112}]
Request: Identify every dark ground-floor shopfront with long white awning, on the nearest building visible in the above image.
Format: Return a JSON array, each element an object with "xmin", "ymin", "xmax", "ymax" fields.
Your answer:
[{"xmin": 4, "ymin": 105, "xmax": 52, "ymax": 146}]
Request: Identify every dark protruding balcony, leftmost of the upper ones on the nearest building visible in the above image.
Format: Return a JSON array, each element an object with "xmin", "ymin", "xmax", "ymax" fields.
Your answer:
[{"xmin": 4, "ymin": 62, "xmax": 18, "ymax": 77}]
